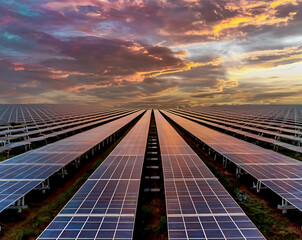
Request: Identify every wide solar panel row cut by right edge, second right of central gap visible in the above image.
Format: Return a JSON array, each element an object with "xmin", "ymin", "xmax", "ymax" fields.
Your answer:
[{"xmin": 163, "ymin": 111, "xmax": 302, "ymax": 211}]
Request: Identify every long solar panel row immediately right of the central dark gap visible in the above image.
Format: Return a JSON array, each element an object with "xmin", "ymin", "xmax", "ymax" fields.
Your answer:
[{"xmin": 155, "ymin": 111, "xmax": 265, "ymax": 240}]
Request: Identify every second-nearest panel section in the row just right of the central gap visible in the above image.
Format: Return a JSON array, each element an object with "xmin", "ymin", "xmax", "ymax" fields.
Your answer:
[{"xmin": 165, "ymin": 178, "xmax": 244, "ymax": 217}]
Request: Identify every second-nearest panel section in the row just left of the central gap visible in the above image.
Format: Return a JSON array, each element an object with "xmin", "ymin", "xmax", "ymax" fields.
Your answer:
[{"xmin": 60, "ymin": 179, "xmax": 140, "ymax": 215}]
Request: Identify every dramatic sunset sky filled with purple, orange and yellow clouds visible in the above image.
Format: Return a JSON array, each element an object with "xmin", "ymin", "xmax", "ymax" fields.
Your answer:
[{"xmin": 0, "ymin": 0, "xmax": 302, "ymax": 107}]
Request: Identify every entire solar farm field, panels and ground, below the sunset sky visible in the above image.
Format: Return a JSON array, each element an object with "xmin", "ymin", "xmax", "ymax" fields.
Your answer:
[{"xmin": 0, "ymin": 104, "xmax": 302, "ymax": 240}]
